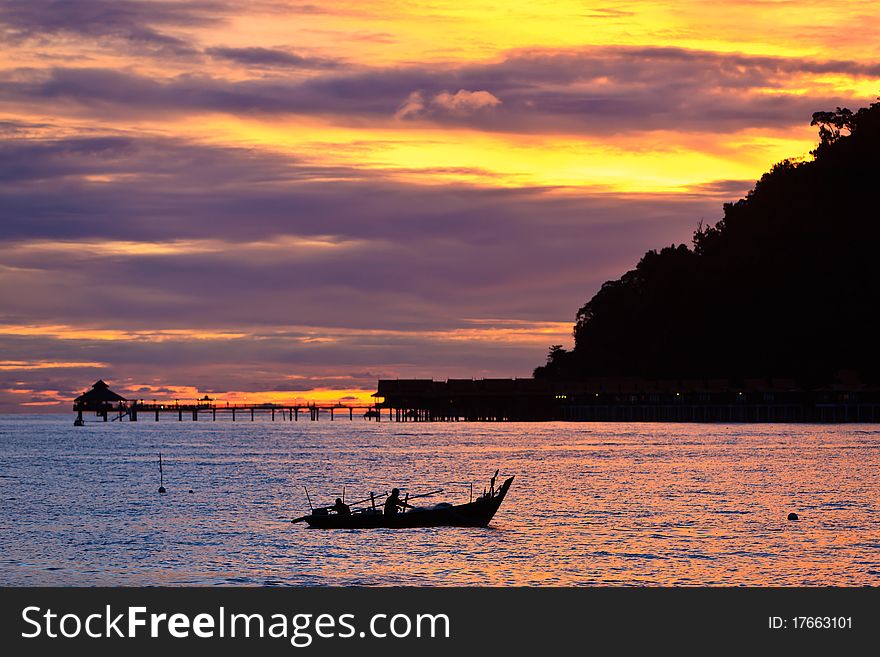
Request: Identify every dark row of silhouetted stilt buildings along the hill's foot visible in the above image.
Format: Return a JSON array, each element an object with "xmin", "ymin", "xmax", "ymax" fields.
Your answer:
[{"xmin": 376, "ymin": 379, "xmax": 880, "ymax": 424}]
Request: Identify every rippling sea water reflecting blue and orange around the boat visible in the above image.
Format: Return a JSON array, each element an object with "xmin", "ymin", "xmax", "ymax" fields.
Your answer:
[{"xmin": 0, "ymin": 415, "xmax": 880, "ymax": 586}]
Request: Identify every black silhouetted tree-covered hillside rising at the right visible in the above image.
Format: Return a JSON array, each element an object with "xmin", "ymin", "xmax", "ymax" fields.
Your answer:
[{"xmin": 535, "ymin": 103, "xmax": 880, "ymax": 387}]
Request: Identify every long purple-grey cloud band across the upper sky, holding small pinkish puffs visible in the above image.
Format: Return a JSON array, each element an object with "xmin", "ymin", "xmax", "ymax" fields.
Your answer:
[{"xmin": 0, "ymin": 48, "xmax": 880, "ymax": 134}]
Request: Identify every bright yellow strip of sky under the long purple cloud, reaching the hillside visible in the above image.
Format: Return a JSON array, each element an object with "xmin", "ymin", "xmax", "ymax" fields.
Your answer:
[{"xmin": 174, "ymin": 117, "xmax": 815, "ymax": 193}]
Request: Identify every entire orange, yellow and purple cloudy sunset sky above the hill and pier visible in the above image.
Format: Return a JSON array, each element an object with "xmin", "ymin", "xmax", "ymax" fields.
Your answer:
[{"xmin": 0, "ymin": 0, "xmax": 880, "ymax": 412}]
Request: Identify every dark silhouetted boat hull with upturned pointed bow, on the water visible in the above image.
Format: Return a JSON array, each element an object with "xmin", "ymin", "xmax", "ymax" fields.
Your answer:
[{"xmin": 292, "ymin": 477, "xmax": 513, "ymax": 529}]
